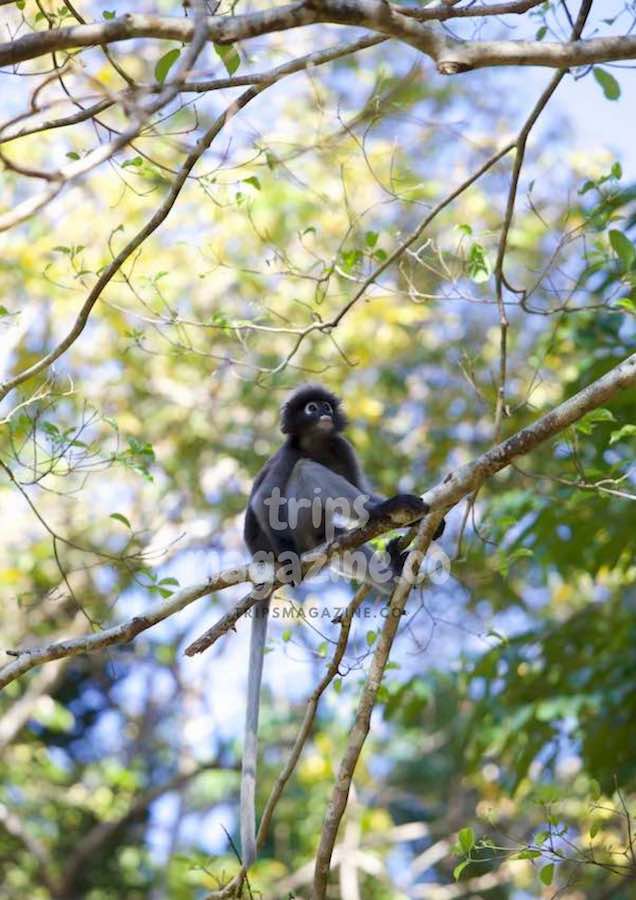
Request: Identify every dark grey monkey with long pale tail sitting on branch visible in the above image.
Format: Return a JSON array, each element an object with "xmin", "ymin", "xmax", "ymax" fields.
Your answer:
[{"xmin": 241, "ymin": 384, "xmax": 443, "ymax": 866}]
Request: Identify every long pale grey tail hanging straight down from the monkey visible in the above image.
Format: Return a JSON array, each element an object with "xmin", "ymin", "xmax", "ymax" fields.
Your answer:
[{"xmin": 241, "ymin": 597, "xmax": 269, "ymax": 866}]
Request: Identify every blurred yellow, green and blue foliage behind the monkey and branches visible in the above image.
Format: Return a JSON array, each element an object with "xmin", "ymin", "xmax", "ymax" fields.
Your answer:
[{"xmin": 0, "ymin": 4, "xmax": 636, "ymax": 900}]
